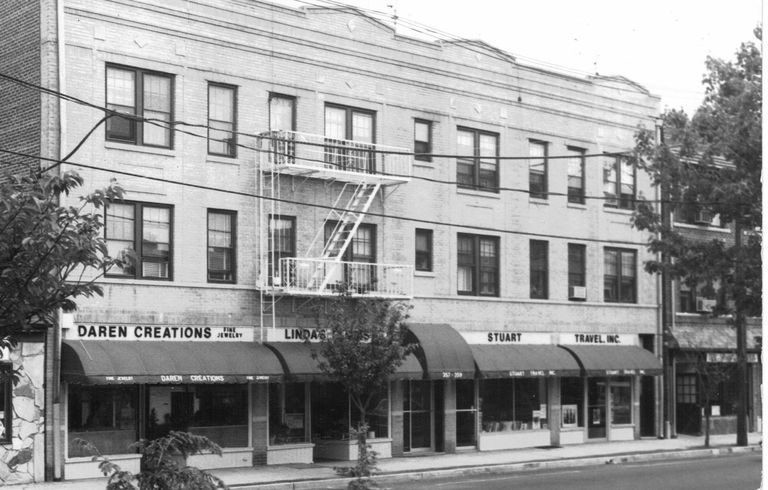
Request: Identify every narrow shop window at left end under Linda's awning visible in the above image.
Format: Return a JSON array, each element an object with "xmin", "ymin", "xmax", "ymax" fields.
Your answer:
[{"xmin": 269, "ymin": 383, "xmax": 307, "ymax": 445}]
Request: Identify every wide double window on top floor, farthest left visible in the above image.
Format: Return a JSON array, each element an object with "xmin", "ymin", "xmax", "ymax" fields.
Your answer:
[{"xmin": 107, "ymin": 65, "xmax": 173, "ymax": 148}]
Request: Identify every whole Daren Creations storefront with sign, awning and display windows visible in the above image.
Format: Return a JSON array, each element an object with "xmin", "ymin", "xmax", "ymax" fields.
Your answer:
[{"xmin": 61, "ymin": 325, "xmax": 283, "ymax": 479}]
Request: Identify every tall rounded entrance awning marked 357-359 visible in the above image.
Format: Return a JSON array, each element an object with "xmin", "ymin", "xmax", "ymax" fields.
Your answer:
[{"xmin": 407, "ymin": 323, "xmax": 475, "ymax": 379}]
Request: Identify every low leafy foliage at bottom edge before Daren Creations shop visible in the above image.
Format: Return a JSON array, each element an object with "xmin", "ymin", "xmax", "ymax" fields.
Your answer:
[{"xmin": 73, "ymin": 431, "xmax": 228, "ymax": 490}]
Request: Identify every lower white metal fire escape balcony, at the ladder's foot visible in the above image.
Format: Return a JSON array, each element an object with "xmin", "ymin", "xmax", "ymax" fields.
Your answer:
[{"xmin": 272, "ymin": 258, "xmax": 413, "ymax": 299}]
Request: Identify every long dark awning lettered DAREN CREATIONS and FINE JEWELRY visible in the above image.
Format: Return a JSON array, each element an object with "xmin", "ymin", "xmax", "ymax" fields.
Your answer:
[{"xmin": 61, "ymin": 340, "xmax": 283, "ymax": 384}]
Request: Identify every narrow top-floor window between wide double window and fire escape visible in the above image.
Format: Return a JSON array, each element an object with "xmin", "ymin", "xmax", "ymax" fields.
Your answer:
[{"xmin": 208, "ymin": 83, "xmax": 237, "ymax": 157}]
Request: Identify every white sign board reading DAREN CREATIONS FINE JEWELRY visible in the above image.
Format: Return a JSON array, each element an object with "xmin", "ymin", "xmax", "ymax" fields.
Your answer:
[{"xmin": 63, "ymin": 324, "xmax": 254, "ymax": 342}]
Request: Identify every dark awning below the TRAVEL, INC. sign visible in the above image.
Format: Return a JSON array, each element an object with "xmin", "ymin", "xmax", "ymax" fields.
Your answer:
[{"xmin": 561, "ymin": 345, "xmax": 662, "ymax": 376}]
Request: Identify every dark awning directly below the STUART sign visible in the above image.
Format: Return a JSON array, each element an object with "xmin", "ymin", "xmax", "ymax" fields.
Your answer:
[{"xmin": 469, "ymin": 344, "xmax": 581, "ymax": 378}]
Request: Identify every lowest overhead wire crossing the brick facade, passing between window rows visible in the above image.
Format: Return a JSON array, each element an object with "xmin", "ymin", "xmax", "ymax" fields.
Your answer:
[{"xmin": 0, "ymin": 148, "xmax": 660, "ymax": 246}]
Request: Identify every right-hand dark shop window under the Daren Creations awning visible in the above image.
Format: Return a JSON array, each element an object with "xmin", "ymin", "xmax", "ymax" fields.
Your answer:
[{"xmin": 147, "ymin": 384, "xmax": 248, "ymax": 447}]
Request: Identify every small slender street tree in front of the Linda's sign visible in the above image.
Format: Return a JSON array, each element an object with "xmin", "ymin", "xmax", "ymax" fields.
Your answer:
[{"xmin": 312, "ymin": 292, "xmax": 413, "ymax": 488}]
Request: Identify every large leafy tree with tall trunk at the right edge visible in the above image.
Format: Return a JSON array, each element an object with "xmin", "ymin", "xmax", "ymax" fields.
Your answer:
[{"xmin": 633, "ymin": 27, "xmax": 762, "ymax": 445}]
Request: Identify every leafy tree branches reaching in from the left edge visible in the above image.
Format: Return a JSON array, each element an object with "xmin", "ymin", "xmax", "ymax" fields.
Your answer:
[{"xmin": 0, "ymin": 172, "xmax": 123, "ymax": 356}]
